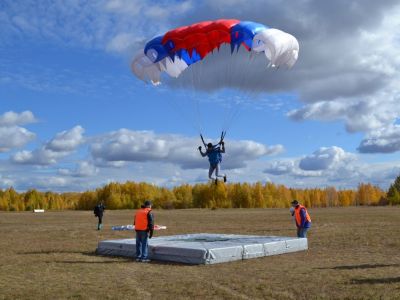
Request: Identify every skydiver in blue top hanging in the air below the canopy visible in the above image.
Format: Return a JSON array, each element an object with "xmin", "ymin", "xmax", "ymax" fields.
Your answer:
[{"xmin": 198, "ymin": 132, "xmax": 226, "ymax": 184}]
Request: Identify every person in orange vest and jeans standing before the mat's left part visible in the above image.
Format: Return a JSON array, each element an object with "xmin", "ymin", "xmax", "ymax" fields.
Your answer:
[{"xmin": 133, "ymin": 200, "xmax": 154, "ymax": 262}]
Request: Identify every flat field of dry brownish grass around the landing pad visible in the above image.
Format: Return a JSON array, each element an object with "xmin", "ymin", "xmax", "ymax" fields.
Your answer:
[{"xmin": 0, "ymin": 207, "xmax": 400, "ymax": 299}]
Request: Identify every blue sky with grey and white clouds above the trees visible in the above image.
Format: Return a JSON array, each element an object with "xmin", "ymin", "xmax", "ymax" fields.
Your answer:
[{"xmin": 0, "ymin": 0, "xmax": 400, "ymax": 191}]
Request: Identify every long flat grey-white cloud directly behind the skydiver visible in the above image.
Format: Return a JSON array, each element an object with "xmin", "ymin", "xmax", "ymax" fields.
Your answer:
[{"xmin": 90, "ymin": 129, "xmax": 283, "ymax": 169}]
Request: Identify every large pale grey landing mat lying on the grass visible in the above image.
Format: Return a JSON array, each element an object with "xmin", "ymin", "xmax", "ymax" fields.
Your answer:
[{"xmin": 96, "ymin": 233, "xmax": 308, "ymax": 264}]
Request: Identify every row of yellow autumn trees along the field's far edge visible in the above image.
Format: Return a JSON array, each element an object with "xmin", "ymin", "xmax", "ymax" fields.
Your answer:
[{"xmin": 0, "ymin": 176, "xmax": 400, "ymax": 211}]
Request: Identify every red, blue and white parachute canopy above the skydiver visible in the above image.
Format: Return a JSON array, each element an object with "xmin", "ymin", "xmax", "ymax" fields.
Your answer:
[{"xmin": 131, "ymin": 19, "xmax": 299, "ymax": 85}]
